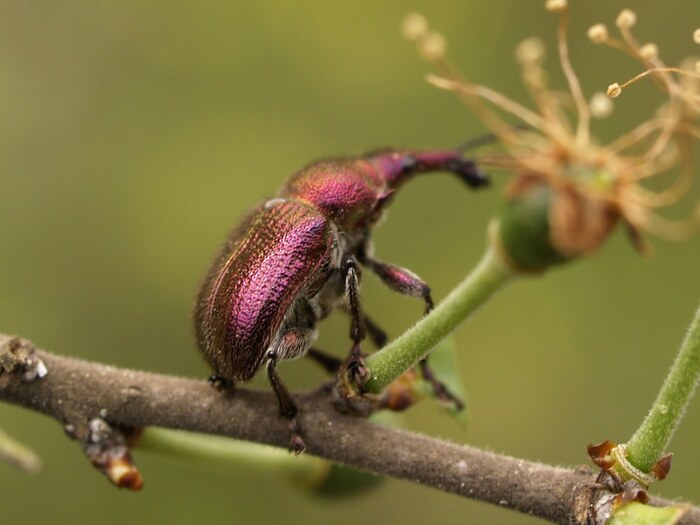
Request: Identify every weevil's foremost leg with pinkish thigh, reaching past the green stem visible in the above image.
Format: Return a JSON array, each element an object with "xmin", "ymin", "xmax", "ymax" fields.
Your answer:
[{"xmin": 362, "ymin": 254, "xmax": 464, "ymax": 410}]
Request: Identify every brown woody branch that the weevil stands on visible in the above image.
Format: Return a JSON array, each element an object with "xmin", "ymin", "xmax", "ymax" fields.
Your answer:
[{"xmin": 0, "ymin": 334, "xmax": 700, "ymax": 524}]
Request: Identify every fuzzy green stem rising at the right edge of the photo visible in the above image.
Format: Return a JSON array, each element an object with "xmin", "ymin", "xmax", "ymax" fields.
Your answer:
[{"xmin": 626, "ymin": 300, "xmax": 700, "ymax": 472}]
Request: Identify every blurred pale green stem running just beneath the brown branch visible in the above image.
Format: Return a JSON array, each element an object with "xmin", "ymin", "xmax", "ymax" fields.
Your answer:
[{"xmin": 137, "ymin": 427, "xmax": 330, "ymax": 485}]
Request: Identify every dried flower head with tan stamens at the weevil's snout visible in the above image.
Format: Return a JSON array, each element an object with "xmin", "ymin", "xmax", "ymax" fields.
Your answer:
[{"xmin": 402, "ymin": 4, "xmax": 700, "ymax": 270}]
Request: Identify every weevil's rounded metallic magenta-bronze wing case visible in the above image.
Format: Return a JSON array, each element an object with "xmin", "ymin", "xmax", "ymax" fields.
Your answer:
[{"xmin": 195, "ymin": 201, "xmax": 332, "ymax": 381}]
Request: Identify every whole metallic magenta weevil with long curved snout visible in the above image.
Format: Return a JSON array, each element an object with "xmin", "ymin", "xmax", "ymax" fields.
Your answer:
[{"xmin": 194, "ymin": 150, "xmax": 488, "ymax": 453}]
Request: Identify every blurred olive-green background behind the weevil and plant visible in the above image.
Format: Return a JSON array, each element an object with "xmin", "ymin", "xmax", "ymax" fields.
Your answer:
[{"xmin": 0, "ymin": 0, "xmax": 700, "ymax": 525}]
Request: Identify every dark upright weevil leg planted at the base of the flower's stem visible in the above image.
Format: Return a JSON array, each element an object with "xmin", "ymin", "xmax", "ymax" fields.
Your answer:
[{"xmin": 343, "ymin": 255, "xmax": 369, "ymax": 392}]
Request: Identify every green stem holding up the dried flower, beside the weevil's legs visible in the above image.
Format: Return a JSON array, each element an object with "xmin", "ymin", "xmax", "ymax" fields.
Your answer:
[{"xmin": 365, "ymin": 247, "xmax": 514, "ymax": 393}]
